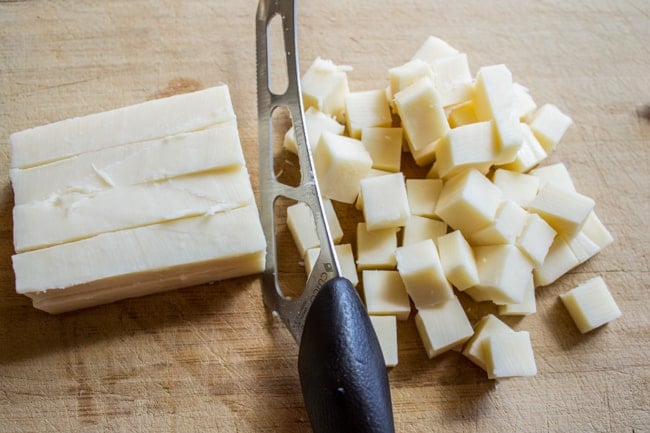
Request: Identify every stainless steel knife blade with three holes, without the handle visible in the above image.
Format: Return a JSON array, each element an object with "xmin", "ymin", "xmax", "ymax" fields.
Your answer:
[{"xmin": 256, "ymin": 0, "xmax": 341, "ymax": 342}]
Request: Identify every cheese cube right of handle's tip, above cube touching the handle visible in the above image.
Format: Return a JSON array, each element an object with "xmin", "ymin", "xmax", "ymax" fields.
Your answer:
[{"xmin": 361, "ymin": 270, "xmax": 411, "ymax": 320}]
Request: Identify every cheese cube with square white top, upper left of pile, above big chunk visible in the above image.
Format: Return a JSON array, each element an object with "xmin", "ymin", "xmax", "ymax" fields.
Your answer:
[{"xmin": 345, "ymin": 89, "xmax": 393, "ymax": 138}]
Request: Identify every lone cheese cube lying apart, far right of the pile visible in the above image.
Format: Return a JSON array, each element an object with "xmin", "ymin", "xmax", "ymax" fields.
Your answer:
[{"xmin": 560, "ymin": 277, "xmax": 621, "ymax": 334}]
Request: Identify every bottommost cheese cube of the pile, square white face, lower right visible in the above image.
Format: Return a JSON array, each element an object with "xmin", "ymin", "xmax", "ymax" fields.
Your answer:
[{"xmin": 483, "ymin": 331, "xmax": 537, "ymax": 379}]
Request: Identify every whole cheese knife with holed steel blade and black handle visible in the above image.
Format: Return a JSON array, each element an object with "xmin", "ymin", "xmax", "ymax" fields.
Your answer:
[{"xmin": 256, "ymin": 0, "xmax": 395, "ymax": 433}]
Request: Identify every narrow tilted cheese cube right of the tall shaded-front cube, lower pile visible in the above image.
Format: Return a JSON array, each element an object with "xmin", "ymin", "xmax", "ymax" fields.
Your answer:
[{"xmin": 438, "ymin": 230, "xmax": 479, "ymax": 291}]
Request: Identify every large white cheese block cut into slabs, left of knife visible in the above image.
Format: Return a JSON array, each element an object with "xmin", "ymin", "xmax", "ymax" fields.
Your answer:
[{"xmin": 11, "ymin": 86, "xmax": 266, "ymax": 313}]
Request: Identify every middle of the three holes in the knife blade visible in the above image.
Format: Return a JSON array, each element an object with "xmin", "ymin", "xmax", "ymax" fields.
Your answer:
[{"xmin": 271, "ymin": 107, "xmax": 301, "ymax": 186}]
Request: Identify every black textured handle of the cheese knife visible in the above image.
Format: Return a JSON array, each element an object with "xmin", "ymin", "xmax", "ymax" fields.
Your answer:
[{"xmin": 298, "ymin": 278, "xmax": 395, "ymax": 433}]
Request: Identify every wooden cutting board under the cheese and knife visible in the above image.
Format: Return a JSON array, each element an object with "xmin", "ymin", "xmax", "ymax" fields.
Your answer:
[{"xmin": 0, "ymin": 0, "xmax": 650, "ymax": 433}]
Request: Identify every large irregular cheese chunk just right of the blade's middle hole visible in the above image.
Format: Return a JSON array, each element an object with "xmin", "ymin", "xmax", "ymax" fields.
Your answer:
[{"xmin": 314, "ymin": 132, "xmax": 372, "ymax": 204}]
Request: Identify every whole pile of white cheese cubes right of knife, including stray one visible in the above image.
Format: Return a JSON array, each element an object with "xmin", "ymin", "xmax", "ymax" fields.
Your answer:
[{"xmin": 285, "ymin": 37, "xmax": 620, "ymax": 378}]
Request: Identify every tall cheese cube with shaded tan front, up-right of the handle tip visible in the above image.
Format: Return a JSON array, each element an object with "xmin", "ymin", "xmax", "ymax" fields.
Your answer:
[{"xmin": 395, "ymin": 239, "xmax": 454, "ymax": 308}]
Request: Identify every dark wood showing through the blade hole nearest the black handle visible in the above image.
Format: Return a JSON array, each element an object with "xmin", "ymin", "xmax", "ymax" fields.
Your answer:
[{"xmin": 274, "ymin": 196, "xmax": 306, "ymax": 298}]
